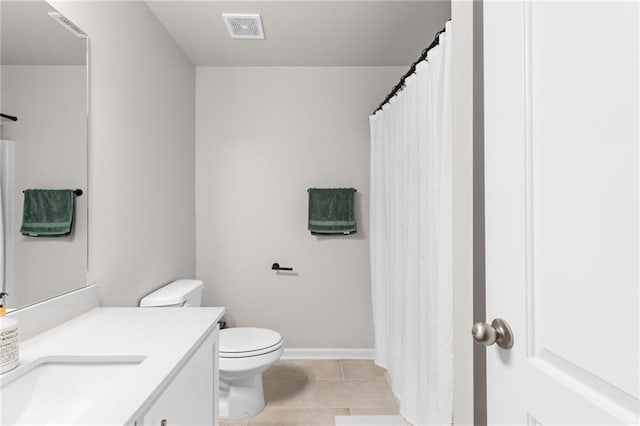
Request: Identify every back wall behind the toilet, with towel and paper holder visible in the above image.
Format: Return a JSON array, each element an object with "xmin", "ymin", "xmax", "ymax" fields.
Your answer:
[{"xmin": 196, "ymin": 67, "xmax": 406, "ymax": 348}]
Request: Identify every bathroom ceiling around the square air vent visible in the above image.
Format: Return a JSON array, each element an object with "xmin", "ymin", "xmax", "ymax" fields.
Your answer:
[{"xmin": 147, "ymin": 0, "xmax": 451, "ymax": 66}]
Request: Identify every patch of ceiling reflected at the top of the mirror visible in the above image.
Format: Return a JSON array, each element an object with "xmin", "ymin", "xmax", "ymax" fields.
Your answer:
[{"xmin": 0, "ymin": 0, "xmax": 87, "ymax": 65}]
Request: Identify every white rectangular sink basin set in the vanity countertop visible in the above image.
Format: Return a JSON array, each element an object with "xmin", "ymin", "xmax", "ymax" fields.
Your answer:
[{"xmin": 0, "ymin": 356, "xmax": 144, "ymax": 425}]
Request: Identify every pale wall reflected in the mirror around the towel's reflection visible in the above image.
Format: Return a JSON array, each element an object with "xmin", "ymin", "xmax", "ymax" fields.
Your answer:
[{"xmin": 0, "ymin": 65, "xmax": 87, "ymax": 308}]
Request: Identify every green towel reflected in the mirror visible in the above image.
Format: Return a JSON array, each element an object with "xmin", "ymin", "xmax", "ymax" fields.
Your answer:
[{"xmin": 20, "ymin": 189, "xmax": 74, "ymax": 237}]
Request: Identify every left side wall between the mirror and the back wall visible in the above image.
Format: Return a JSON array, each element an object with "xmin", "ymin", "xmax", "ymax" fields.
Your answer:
[{"xmin": 50, "ymin": 0, "xmax": 195, "ymax": 306}]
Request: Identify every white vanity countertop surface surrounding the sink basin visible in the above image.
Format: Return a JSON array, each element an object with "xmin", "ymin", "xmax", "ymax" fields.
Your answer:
[{"xmin": 10, "ymin": 308, "xmax": 225, "ymax": 425}]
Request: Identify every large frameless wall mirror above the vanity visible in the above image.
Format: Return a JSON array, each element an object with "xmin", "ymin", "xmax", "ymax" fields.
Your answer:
[{"xmin": 0, "ymin": 0, "xmax": 90, "ymax": 309}]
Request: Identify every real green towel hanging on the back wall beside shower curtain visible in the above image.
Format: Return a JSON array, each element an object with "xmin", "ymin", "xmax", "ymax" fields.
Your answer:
[{"xmin": 308, "ymin": 188, "xmax": 356, "ymax": 234}]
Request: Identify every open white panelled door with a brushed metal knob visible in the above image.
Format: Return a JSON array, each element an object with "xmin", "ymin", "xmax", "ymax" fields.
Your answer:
[{"xmin": 484, "ymin": 0, "xmax": 640, "ymax": 425}]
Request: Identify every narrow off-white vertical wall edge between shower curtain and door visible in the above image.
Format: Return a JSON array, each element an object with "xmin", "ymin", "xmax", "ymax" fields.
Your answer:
[{"xmin": 451, "ymin": 0, "xmax": 474, "ymax": 425}]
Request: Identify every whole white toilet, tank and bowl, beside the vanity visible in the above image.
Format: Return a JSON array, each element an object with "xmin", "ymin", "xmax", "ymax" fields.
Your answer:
[{"xmin": 140, "ymin": 280, "xmax": 284, "ymax": 420}]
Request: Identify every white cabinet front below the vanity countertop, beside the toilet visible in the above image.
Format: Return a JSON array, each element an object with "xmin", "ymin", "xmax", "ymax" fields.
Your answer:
[{"xmin": 135, "ymin": 326, "xmax": 219, "ymax": 426}]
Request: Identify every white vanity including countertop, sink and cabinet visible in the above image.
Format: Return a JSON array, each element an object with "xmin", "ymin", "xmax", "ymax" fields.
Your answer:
[{"xmin": 0, "ymin": 294, "xmax": 224, "ymax": 426}]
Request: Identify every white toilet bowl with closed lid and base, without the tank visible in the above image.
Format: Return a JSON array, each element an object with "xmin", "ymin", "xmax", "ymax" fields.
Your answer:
[{"xmin": 219, "ymin": 327, "xmax": 283, "ymax": 420}]
